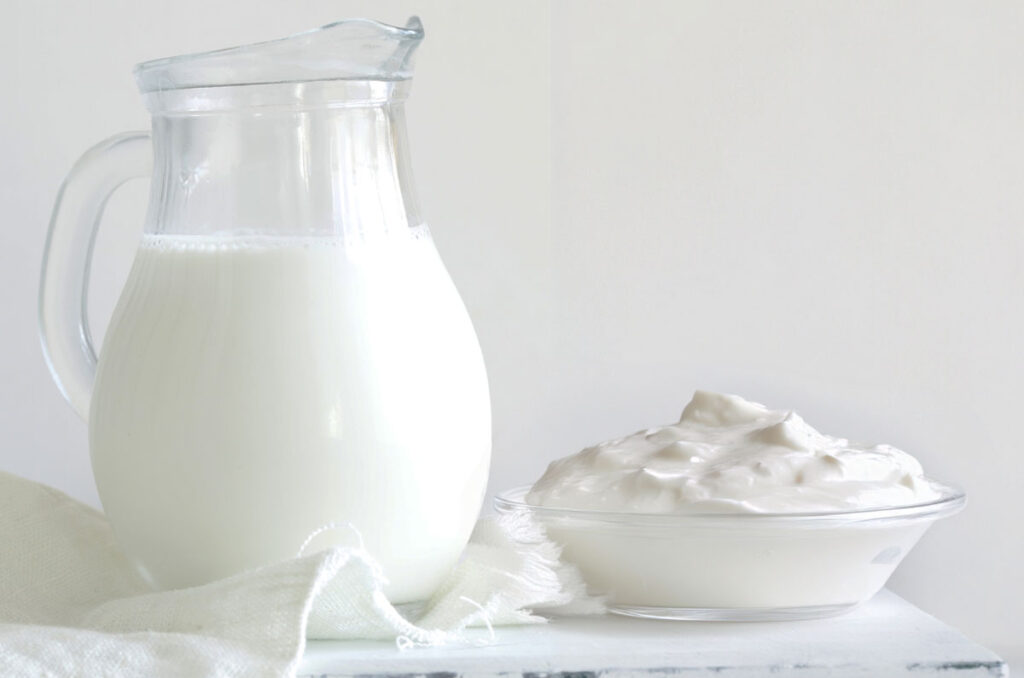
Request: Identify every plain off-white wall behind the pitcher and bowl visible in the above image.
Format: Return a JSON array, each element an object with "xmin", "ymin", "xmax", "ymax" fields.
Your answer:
[{"xmin": 0, "ymin": 0, "xmax": 1024, "ymax": 656}]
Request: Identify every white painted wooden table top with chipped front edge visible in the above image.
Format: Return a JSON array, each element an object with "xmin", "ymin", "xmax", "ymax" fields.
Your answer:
[{"xmin": 298, "ymin": 591, "xmax": 1009, "ymax": 678}]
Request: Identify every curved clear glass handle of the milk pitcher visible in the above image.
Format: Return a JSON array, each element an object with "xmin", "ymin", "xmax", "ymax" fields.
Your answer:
[{"xmin": 39, "ymin": 132, "xmax": 153, "ymax": 421}]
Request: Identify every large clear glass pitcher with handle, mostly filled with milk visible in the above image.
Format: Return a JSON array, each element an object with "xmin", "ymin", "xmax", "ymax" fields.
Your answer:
[{"xmin": 40, "ymin": 17, "xmax": 490, "ymax": 602}]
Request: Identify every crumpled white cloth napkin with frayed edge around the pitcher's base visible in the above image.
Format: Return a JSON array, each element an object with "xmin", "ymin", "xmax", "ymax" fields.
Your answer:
[{"xmin": 0, "ymin": 472, "xmax": 601, "ymax": 678}]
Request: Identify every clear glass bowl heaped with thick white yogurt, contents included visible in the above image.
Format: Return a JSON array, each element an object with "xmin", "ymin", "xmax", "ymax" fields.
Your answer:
[{"xmin": 496, "ymin": 391, "xmax": 966, "ymax": 621}]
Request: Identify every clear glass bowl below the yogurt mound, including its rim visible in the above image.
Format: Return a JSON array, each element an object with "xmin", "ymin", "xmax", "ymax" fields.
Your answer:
[{"xmin": 495, "ymin": 484, "xmax": 967, "ymax": 622}]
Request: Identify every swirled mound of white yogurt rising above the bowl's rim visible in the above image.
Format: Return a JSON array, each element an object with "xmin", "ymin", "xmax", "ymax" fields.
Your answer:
[{"xmin": 526, "ymin": 391, "xmax": 941, "ymax": 513}]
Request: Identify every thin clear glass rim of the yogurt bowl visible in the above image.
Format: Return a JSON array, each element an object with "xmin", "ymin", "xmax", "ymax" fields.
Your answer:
[{"xmin": 494, "ymin": 479, "xmax": 967, "ymax": 527}]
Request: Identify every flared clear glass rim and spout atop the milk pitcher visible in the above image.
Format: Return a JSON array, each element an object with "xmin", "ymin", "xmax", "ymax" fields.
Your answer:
[{"xmin": 135, "ymin": 16, "xmax": 424, "ymax": 94}]
